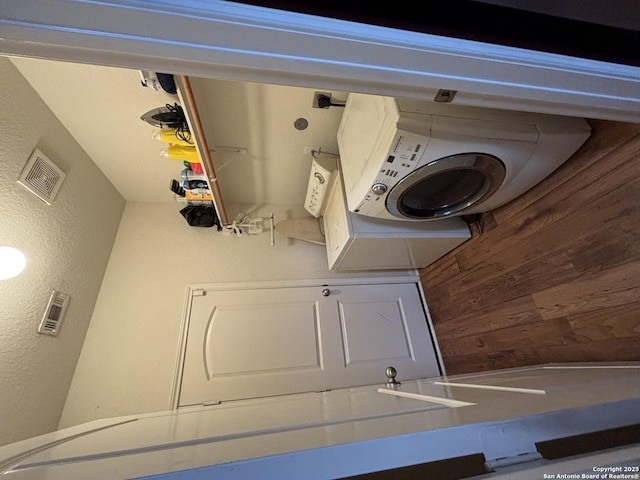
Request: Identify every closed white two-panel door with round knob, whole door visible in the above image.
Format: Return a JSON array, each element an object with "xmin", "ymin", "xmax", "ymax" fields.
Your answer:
[{"xmin": 179, "ymin": 284, "xmax": 440, "ymax": 406}]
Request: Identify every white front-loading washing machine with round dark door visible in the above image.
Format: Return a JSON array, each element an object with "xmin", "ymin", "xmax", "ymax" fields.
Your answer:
[{"xmin": 338, "ymin": 94, "xmax": 591, "ymax": 221}]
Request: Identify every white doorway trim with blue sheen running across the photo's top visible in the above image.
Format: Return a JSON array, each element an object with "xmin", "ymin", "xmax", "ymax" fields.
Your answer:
[{"xmin": 0, "ymin": 0, "xmax": 640, "ymax": 122}]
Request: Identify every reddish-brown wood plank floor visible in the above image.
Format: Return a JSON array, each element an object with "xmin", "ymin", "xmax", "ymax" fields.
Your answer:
[{"xmin": 420, "ymin": 121, "xmax": 640, "ymax": 374}]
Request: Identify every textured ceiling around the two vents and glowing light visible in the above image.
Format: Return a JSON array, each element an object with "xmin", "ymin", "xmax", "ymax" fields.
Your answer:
[{"xmin": 0, "ymin": 58, "xmax": 124, "ymax": 445}]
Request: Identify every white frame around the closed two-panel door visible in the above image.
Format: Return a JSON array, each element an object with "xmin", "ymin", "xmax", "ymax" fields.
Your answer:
[{"xmin": 170, "ymin": 270, "xmax": 446, "ymax": 410}]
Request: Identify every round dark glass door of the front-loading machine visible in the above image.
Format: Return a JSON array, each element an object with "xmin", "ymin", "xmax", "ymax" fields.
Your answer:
[{"xmin": 387, "ymin": 153, "xmax": 506, "ymax": 220}]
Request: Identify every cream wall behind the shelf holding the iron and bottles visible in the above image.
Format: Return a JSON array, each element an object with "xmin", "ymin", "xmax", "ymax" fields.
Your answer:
[{"xmin": 12, "ymin": 58, "xmax": 346, "ymax": 205}]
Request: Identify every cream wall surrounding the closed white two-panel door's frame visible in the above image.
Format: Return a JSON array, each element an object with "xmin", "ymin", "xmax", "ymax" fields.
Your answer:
[{"xmin": 60, "ymin": 202, "xmax": 409, "ymax": 428}]
